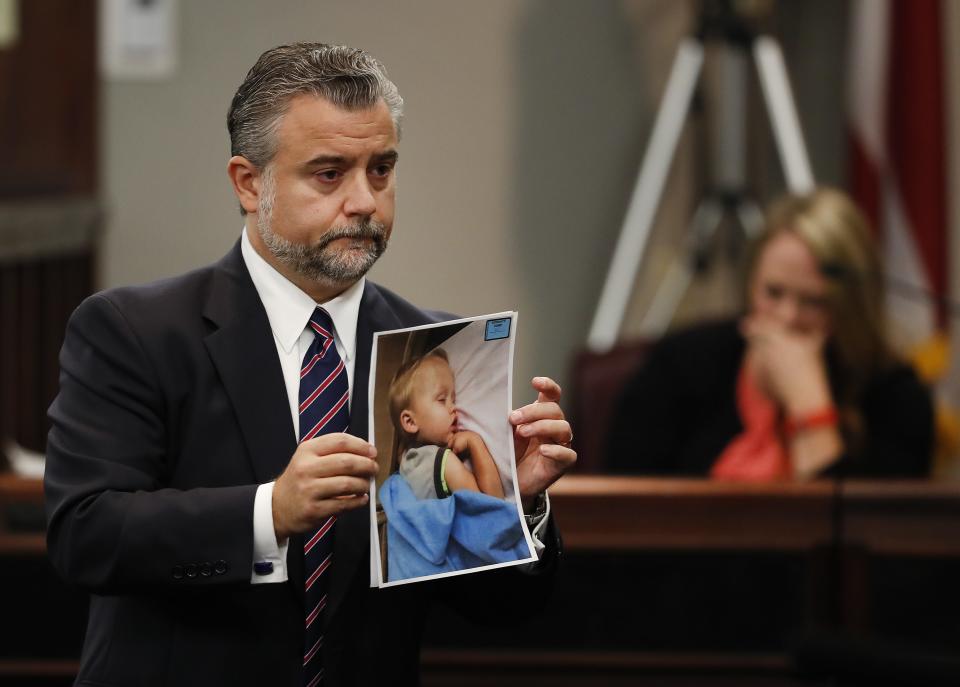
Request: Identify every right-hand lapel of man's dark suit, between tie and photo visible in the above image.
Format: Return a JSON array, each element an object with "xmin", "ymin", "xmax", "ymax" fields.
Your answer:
[{"xmin": 324, "ymin": 281, "xmax": 403, "ymax": 623}]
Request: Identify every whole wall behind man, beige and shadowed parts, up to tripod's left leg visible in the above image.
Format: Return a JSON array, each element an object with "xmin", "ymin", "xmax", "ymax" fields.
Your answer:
[{"xmin": 100, "ymin": 0, "xmax": 688, "ymax": 400}]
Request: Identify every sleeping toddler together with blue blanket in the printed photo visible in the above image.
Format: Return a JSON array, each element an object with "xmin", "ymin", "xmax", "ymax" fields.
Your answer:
[{"xmin": 378, "ymin": 349, "xmax": 532, "ymax": 582}]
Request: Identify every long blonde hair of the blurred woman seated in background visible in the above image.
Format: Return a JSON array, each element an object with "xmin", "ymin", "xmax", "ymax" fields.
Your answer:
[{"xmin": 747, "ymin": 187, "xmax": 893, "ymax": 436}]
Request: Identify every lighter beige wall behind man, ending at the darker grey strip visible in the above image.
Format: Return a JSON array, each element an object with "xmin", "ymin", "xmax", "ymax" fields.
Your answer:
[{"xmin": 101, "ymin": 0, "xmax": 540, "ymax": 406}]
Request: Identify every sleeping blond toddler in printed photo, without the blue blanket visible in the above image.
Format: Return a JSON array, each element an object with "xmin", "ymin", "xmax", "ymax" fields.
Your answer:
[{"xmin": 389, "ymin": 349, "xmax": 504, "ymax": 499}]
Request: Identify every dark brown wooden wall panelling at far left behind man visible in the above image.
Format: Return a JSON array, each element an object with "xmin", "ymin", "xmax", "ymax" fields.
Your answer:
[{"xmin": 0, "ymin": 0, "xmax": 100, "ymax": 455}]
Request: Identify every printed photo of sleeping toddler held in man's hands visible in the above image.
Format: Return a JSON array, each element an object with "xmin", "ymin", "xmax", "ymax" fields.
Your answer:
[{"xmin": 370, "ymin": 316, "xmax": 534, "ymax": 585}]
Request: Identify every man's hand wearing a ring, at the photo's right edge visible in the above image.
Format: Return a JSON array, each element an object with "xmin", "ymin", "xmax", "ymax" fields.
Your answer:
[{"xmin": 510, "ymin": 377, "xmax": 577, "ymax": 508}]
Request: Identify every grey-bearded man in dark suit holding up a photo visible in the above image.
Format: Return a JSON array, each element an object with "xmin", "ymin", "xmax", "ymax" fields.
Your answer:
[{"xmin": 45, "ymin": 44, "xmax": 576, "ymax": 685}]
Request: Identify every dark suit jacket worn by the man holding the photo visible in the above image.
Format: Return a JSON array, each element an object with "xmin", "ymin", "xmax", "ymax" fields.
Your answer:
[{"xmin": 45, "ymin": 244, "xmax": 557, "ymax": 687}]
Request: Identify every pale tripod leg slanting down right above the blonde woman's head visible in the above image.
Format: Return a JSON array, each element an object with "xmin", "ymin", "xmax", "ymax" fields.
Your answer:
[{"xmin": 753, "ymin": 36, "xmax": 813, "ymax": 193}]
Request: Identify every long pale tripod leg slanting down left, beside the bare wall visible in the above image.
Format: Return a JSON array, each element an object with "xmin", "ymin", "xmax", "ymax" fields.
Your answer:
[{"xmin": 587, "ymin": 38, "xmax": 703, "ymax": 351}]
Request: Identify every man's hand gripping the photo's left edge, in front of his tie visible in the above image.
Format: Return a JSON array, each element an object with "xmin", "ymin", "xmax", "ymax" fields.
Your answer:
[{"xmin": 273, "ymin": 433, "xmax": 377, "ymax": 542}]
